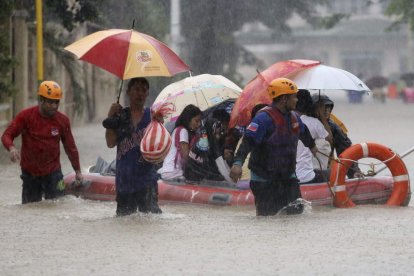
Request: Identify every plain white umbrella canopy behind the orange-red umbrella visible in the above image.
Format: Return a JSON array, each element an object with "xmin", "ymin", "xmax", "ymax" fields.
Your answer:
[{"xmin": 286, "ymin": 64, "xmax": 371, "ymax": 92}]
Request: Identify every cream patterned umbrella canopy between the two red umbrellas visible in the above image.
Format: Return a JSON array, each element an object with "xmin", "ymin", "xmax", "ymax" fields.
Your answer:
[{"xmin": 152, "ymin": 74, "xmax": 241, "ymax": 122}]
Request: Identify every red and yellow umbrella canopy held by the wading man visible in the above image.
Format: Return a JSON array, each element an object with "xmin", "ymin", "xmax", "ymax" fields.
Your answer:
[{"xmin": 65, "ymin": 29, "xmax": 190, "ymax": 80}]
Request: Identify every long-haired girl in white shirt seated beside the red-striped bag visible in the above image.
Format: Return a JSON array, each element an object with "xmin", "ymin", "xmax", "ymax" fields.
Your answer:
[{"xmin": 158, "ymin": 104, "xmax": 201, "ymax": 181}]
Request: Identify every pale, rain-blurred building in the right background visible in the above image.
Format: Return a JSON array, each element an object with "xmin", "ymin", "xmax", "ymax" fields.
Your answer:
[{"xmin": 236, "ymin": 0, "xmax": 413, "ymax": 82}]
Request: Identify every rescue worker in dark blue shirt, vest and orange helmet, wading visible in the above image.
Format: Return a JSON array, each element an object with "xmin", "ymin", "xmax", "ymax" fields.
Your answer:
[{"xmin": 230, "ymin": 78, "xmax": 316, "ymax": 216}]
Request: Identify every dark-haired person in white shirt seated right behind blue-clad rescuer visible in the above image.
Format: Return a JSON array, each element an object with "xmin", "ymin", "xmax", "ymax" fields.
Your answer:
[{"xmin": 296, "ymin": 89, "xmax": 332, "ymax": 184}]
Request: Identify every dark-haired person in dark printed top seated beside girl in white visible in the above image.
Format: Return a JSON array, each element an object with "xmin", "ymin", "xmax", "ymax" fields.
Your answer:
[{"xmin": 184, "ymin": 108, "xmax": 230, "ymax": 183}]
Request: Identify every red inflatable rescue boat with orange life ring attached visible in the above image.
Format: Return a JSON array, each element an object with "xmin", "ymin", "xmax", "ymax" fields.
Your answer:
[{"xmin": 64, "ymin": 143, "xmax": 411, "ymax": 207}]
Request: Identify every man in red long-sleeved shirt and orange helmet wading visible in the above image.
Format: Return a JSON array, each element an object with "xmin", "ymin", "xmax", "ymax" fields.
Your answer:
[{"xmin": 1, "ymin": 81, "xmax": 83, "ymax": 204}]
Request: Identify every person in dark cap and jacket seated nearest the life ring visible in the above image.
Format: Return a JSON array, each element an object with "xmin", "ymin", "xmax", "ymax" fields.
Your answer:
[{"xmin": 312, "ymin": 93, "xmax": 364, "ymax": 178}]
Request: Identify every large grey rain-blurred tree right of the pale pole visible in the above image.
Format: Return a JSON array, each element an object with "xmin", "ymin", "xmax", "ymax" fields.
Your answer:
[{"xmin": 181, "ymin": 0, "xmax": 344, "ymax": 83}]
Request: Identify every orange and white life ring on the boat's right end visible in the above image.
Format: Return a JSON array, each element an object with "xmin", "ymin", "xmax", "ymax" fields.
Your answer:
[{"xmin": 329, "ymin": 143, "xmax": 410, "ymax": 208}]
